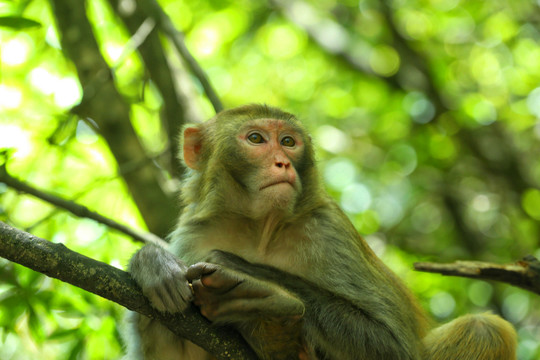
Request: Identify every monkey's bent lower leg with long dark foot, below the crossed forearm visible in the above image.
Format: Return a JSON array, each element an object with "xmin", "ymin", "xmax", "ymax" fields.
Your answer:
[{"xmin": 186, "ymin": 259, "xmax": 307, "ymax": 360}]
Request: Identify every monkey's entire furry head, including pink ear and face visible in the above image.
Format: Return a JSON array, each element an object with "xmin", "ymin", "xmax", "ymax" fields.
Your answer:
[{"xmin": 182, "ymin": 105, "xmax": 318, "ymax": 219}]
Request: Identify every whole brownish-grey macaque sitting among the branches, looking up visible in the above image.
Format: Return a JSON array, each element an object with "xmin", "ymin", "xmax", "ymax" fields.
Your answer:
[{"xmin": 126, "ymin": 105, "xmax": 516, "ymax": 360}]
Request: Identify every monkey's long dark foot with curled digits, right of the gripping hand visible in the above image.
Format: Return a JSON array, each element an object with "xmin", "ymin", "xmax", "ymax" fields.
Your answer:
[{"xmin": 186, "ymin": 262, "xmax": 305, "ymax": 323}]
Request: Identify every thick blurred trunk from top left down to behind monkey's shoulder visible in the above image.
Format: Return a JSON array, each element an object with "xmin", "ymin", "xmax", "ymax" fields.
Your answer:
[{"xmin": 51, "ymin": 0, "xmax": 177, "ymax": 236}]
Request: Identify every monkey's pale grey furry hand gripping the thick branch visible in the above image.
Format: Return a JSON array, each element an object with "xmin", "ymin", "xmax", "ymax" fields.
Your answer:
[{"xmin": 129, "ymin": 245, "xmax": 193, "ymax": 313}]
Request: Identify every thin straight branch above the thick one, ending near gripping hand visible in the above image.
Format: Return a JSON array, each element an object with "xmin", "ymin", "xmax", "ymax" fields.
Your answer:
[{"xmin": 0, "ymin": 165, "xmax": 167, "ymax": 247}]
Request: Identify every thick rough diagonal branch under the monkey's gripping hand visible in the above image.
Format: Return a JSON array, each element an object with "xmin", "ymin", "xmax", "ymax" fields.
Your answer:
[{"xmin": 0, "ymin": 222, "xmax": 256, "ymax": 359}]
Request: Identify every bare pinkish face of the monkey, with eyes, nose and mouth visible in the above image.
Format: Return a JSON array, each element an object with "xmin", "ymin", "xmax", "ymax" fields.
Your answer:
[{"xmin": 236, "ymin": 119, "xmax": 304, "ymax": 217}]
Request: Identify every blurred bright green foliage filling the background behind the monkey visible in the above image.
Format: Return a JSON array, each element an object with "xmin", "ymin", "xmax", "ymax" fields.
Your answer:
[{"xmin": 0, "ymin": 0, "xmax": 540, "ymax": 360}]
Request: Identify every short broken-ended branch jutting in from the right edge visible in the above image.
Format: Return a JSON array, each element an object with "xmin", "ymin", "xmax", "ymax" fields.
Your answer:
[{"xmin": 414, "ymin": 255, "xmax": 540, "ymax": 294}]
